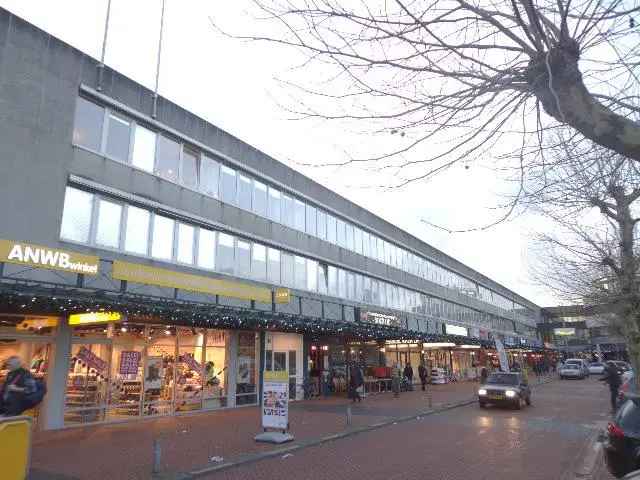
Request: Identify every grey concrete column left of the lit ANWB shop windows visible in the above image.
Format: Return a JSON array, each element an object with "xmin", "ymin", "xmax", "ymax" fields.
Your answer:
[{"xmin": 41, "ymin": 318, "xmax": 72, "ymax": 430}]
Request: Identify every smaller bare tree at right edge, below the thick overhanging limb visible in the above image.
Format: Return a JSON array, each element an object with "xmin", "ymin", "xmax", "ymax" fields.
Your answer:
[{"xmin": 523, "ymin": 142, "xmax": 640, "ymax": 382}]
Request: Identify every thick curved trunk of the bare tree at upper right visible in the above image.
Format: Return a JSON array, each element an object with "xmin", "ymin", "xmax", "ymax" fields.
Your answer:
[{"xmin": 527, "ymin": 40, "xmax": 640, "ymax": 161}]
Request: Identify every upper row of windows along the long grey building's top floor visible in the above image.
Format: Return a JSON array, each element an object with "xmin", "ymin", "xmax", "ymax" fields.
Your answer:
[{"xmin": 73, "ymin": 97, "xmax": 527, "ymax": 320}]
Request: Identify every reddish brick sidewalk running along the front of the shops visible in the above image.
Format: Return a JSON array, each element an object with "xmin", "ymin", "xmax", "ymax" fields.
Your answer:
[{"xmin": 31, "ymin": 382, "xmax": 490, "ymax": 480}]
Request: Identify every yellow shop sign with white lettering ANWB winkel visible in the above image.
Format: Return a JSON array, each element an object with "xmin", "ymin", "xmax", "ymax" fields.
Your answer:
[{"xmin": 0, "ymin": 240, "xmax": 100, "ymax": 275}]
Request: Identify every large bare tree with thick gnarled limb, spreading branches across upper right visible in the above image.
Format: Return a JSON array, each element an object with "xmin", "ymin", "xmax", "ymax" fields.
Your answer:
[{"xmin": 220, "ymin": 0, "xmax": 640, "ymax": 185}]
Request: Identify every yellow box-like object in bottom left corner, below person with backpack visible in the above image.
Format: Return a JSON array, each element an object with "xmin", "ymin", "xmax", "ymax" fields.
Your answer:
[{"xmin": 0, "ymin": 417, "xmax": 31, "ymax": 480}]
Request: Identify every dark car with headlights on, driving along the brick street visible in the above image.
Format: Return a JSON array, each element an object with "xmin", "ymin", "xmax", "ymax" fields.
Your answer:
[{"xmin": 478, "ymin": 372, "xmax": 531, "ymax": 410}]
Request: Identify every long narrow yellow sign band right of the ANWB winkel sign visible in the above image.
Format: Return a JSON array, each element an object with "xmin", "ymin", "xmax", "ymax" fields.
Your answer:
[{"xmin": 111, "ymin": 260, "xmax": 271, "ymax": 303}]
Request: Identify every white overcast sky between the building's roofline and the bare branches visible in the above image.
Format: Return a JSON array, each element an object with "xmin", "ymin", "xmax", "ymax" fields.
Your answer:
[{"xmin": 0, "ymin": 0, "xmax": 558, "ymax": 306}]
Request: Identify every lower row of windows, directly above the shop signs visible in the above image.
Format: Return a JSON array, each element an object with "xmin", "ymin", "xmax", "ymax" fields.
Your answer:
[{"xmin": 60, "ymin": 187, "xmax": 514, "ymax": 331}]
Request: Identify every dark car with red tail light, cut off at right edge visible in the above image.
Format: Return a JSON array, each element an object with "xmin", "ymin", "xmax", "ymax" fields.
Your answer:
[{"xmin": 603, "ymin": 393, "xmax": 640, "ymax": 478}]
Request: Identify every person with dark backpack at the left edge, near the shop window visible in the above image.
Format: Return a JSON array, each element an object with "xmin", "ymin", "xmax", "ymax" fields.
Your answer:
[{"xmin": 0, "ymin": 356, "xmax": 46, "ymax": 417}]
